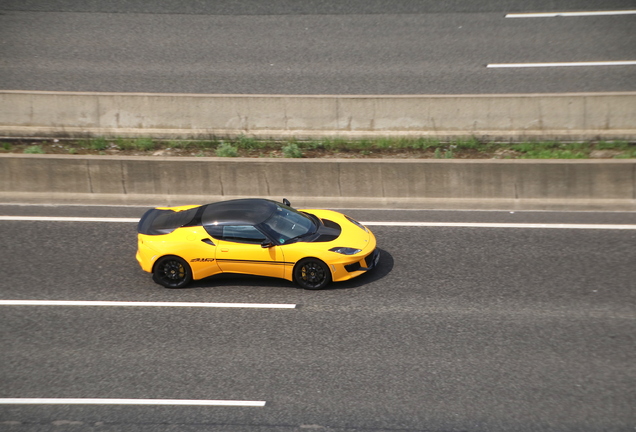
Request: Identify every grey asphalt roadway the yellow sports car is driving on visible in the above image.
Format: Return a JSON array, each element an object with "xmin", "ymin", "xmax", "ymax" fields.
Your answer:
[{"xmin": 0, "ymin": 205, "xmax": 636, "ymax": 432}]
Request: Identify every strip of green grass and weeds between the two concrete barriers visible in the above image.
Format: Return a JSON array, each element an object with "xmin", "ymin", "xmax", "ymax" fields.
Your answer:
[{"xmin": 0, "ymin": 135, "xmax": 636, "ymax": 159}]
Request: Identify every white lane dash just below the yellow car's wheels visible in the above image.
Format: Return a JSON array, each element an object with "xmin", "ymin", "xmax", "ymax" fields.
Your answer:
[{"xmin": 0, "ymin": 300, "xmax": 296, "ymax": 309}]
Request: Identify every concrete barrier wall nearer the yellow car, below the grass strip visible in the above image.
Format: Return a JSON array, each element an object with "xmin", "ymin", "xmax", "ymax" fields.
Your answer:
[{"xmin": 0, "ymin": 154, "xmax": 636, "ymax": 210}]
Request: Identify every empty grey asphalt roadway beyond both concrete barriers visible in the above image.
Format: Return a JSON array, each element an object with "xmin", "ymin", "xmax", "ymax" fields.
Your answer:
[{"xmin": 0, "ymin": 0, "xmax": 636, "ymax": 94}]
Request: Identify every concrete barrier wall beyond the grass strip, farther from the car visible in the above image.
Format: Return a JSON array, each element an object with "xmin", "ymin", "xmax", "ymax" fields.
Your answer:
[{"xmin": 0, "ymin": 91, "xmax": 636, "ymax": 140}]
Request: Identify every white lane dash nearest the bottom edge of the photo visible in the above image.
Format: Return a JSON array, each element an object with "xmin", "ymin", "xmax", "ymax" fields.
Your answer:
[{"xmin": 0, "ymin": 398, "xmax": 266, "ymax": 407}]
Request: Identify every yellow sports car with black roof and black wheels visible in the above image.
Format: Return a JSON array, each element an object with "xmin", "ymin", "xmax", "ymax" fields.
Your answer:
[{"xmin": 137, "ymin": 199, "xmax": 380, "ymax": 289}]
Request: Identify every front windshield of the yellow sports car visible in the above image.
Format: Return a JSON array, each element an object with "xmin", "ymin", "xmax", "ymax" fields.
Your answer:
[{"xmin": 259, "ymin": 204, "xmax": 318, "ymax": 244}]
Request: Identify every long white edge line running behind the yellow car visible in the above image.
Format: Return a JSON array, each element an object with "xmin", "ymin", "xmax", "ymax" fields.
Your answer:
[{"xmin": 0, "ymin": 216, "xmax": 636, "ymax": 230}]
